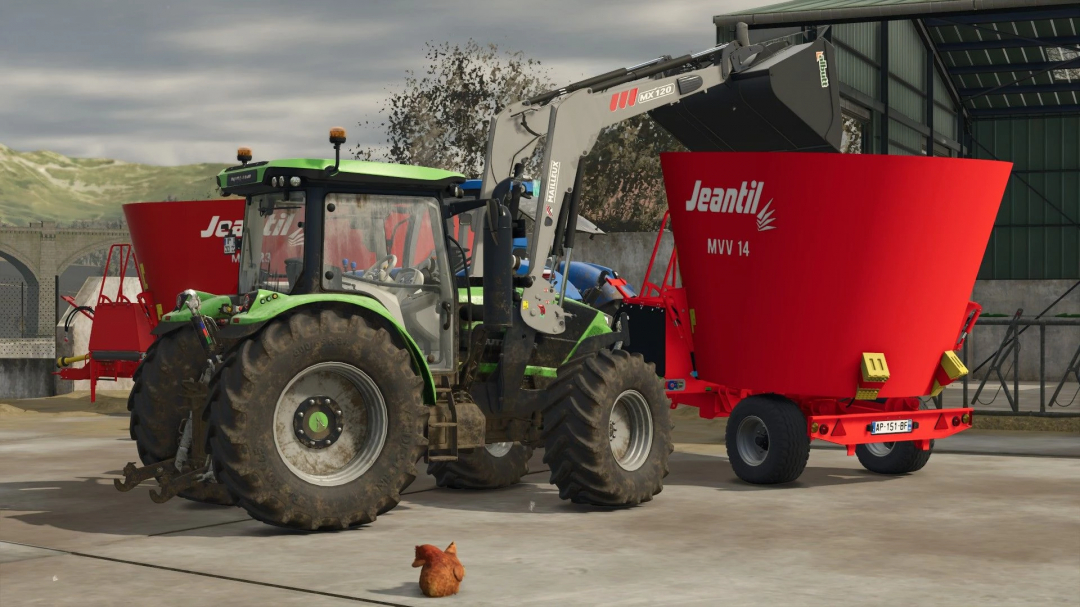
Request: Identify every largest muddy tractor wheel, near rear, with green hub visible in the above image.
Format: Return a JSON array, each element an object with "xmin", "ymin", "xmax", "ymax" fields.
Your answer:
[{"xmin": 210, "ymin": 309, "xmax": 428, "ymax": 530}]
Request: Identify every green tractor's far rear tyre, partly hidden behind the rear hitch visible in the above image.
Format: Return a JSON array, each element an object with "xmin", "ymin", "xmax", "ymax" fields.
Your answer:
[{"xmin": 127, "ymin": 327, "xmax": 237, "ymax": 505}]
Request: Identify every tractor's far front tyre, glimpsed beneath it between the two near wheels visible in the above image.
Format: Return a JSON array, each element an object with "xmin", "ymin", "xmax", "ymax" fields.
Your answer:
[{"xmin": 428, "ymin": 443, "xmax": 532, "ymax": 489}]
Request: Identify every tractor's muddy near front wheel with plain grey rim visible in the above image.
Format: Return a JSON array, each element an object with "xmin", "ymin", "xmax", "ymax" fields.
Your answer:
[{"xmin": 543, "ymin": 350, "xmax": 674, "ymax": 507}]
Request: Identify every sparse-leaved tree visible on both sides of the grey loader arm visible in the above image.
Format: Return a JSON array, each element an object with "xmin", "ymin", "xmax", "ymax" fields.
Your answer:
[{"xmin": 362, "ymin": 40, "xmax": 683, "ymax": 231}]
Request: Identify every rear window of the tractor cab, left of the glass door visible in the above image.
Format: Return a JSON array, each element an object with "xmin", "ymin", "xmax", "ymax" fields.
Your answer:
[{"xmin": 240, "ymin": 191, "xmax": 305, "ymax": 294}]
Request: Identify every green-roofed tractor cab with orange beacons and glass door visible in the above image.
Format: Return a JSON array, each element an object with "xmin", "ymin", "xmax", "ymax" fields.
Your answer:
[{"xmin": 218, "ymin": 130, "xmax": 464, "ymax": 370}]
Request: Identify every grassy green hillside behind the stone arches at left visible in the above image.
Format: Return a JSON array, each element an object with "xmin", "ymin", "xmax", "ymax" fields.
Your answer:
[{"xmin": 0, "ymin": 144, "xmax": 227, "ymax": 226}]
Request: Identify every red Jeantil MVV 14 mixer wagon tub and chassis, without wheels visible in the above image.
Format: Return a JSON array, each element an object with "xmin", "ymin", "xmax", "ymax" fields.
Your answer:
[{"xmin": 626, "ymin": 153, "xmax": 1010, "ymax": 455}]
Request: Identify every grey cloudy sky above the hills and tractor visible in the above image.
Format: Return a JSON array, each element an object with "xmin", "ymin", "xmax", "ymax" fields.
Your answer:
[{"xmin": 0, "ymin": 0, "xmax": 775, "ymax": 164}]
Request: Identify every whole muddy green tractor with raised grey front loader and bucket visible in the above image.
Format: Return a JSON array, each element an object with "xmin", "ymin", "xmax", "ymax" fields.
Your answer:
[{"xmin": 117, "ymin": 29, "xmax": 816, "ymax": 529}]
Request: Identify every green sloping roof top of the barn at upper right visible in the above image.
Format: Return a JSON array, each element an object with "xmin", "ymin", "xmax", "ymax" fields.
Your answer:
[{"xmin": 713, "ymin": 0, "xmax": 1076, "ymax": 26}]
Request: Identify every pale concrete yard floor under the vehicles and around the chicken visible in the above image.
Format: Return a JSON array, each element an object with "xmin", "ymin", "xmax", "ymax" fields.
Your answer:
[{"xmin": 0, "ymin": 388, "xmax": 1080, "ymax": 607}]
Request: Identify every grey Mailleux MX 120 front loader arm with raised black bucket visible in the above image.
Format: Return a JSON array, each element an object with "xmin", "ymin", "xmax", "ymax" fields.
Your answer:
[{"xmin": 472, "ymin": 24, "xmax": 841, "ymax": 335}]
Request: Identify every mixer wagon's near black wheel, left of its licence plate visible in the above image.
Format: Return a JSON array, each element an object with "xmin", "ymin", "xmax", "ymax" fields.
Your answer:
[{"xmin": 725, "ymin": 394, "xmax": 810, "ymax": 485}]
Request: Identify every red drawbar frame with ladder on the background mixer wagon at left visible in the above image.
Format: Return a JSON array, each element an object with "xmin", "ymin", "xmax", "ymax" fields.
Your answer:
[{"xmin": 56, "ymin": 244, "xmax": 158, "ymax": 402}]
